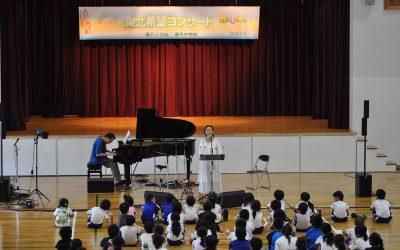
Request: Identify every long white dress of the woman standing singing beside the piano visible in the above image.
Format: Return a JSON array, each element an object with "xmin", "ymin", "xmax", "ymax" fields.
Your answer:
[{"xmin": 198, "ymin": 138, "xmax": 222, "ymax": 194}]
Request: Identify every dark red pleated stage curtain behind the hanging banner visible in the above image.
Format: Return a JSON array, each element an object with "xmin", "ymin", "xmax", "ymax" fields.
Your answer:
[{"xmin": 0, "ymin": 0, "xmax": 350, "ymax": 129}]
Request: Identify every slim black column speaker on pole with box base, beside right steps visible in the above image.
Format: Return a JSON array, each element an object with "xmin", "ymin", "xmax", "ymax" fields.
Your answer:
[{"xmin": 355, "ymin": 100, "xmax": 372, "ymax": 197}]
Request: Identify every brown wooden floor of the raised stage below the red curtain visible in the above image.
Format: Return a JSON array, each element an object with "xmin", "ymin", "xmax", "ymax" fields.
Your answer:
[{"xmin": 7, "ymin": 116, "xmax": 353, "ymax": 137}]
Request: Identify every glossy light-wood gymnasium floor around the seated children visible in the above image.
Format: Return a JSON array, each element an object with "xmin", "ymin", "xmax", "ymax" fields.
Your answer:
[{"xmin": 0, "ymin": 173, "xmax": 400, "ymax": 249}]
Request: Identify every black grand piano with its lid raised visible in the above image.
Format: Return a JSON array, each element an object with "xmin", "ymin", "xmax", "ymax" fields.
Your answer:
[{"xmin": 113, "ymin": 109, "xmax": 196, "ymax": 184}]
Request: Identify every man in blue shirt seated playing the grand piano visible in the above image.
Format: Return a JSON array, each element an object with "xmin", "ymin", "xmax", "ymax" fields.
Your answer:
[{"xmin": 90, "ymin": 133, "xmax": 123, "ymax": 186}]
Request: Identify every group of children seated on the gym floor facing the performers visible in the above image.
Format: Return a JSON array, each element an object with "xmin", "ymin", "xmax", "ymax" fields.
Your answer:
[{"xmin": 54, "ymin": 189, "xmax": 392, "ymax": 250}]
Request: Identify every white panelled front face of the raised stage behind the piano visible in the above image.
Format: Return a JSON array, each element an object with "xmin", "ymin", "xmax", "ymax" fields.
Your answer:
[{"xmin": 0, "ymin": 134, "xmax": 356, "ymax": 178}]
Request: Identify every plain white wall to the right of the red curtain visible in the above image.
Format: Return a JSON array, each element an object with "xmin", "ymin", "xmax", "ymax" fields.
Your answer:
[{"xmin": 350, "ymin": 0, "xmax": 400, "ymax": 163}]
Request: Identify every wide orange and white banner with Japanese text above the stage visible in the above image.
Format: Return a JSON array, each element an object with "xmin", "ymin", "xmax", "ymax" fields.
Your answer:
[{"xmin": 79, "ymin": 6, "xmax": 260, "ymax": 40}]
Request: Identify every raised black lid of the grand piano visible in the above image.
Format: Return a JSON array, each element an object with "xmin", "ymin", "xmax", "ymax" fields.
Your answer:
[{"xmin": 136, "ymin": 108, "xmax": 196, "ymax": 139}]
